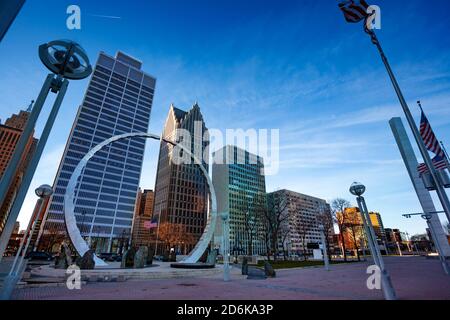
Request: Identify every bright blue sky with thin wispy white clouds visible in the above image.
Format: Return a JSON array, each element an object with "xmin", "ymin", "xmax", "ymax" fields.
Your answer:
[{"xmin": 0, "ymin": 0, "xmax": 450, "ymax": 234}]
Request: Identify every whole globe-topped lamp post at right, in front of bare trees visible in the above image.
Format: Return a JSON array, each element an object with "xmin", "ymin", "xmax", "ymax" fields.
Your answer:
[{"xmin": 350, "ymin": 182, "xmax": 397, "ymax": 300}]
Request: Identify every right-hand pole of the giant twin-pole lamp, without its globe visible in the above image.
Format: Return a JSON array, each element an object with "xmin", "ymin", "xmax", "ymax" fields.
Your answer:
[{"xmin": 0, "ymin": 79, "xmax": 69, "ymax": 261}]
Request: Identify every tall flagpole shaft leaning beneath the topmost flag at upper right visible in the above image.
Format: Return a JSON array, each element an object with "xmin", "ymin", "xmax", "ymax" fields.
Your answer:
[{"xmin": 364, "ymin": 28, "xmax": 450, "ymax": 221}]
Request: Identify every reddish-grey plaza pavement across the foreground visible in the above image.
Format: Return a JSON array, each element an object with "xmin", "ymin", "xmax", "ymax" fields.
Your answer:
[{"xmin": 13, "ymin": 257, "xmax": 450, "ymax": 300}]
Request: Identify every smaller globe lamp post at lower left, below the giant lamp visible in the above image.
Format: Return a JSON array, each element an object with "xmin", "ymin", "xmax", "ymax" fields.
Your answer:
[{"xmin": 0, "ymin": 184, "xmax": 53, "ymax": 300}]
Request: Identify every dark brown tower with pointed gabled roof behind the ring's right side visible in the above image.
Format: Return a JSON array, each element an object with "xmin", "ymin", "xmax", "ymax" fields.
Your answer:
[{"xmin": 153, "ymin": 103, "xmax": 209, "ymax": 249}]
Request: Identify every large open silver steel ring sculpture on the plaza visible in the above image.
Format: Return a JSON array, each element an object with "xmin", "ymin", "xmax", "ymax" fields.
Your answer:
[{"xmin": 64, "ymin": 132, "xmax": 217, "ymax": 266}]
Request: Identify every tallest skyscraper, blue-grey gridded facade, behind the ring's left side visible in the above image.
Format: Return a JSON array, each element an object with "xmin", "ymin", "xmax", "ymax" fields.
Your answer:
[{"xmin": 40, "ymin": 52, "xmax": 156, "ymax": 252}]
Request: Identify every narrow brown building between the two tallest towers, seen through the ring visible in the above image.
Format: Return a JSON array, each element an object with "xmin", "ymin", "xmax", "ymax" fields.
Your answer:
[{"xmin": 131, "ymin": 190, "xmax": 154, "ymax": 247}]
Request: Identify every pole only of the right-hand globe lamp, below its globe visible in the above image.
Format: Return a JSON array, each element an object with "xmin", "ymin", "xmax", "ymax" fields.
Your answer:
[{"xmin": 357, "ymin": 196, "xmax": 397, "ymax": 300}]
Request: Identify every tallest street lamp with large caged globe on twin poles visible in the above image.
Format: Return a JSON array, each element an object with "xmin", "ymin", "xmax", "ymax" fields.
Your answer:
[{"xmin": 0, "ymin": 40, "xmax": 92, "ymax": 261}]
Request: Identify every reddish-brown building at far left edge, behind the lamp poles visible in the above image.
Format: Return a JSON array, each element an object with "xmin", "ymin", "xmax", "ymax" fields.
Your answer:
[{"xmin": 0, "ymin": 106, "xmax": 37, "ymax": 234}]
